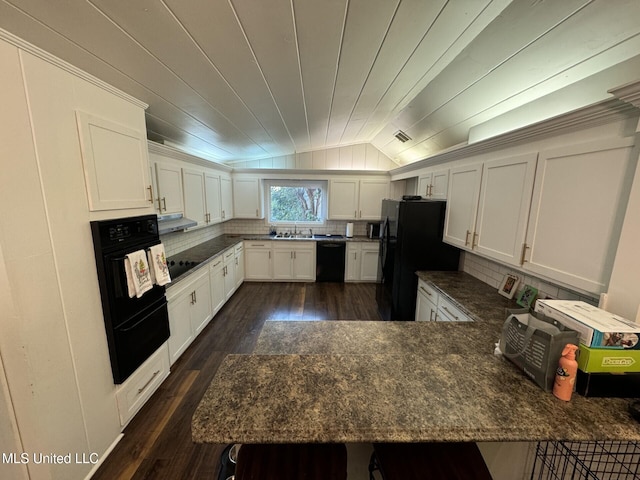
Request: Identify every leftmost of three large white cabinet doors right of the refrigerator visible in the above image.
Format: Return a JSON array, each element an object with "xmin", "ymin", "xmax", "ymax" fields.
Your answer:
[{"xmin": 444, "ymin": 163, "xmax": 482, "ymax": 248}]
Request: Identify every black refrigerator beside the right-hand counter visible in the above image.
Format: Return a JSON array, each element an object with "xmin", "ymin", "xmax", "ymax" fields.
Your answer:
[{"xmin": 376, "ymin": 200, "xmax": 460, "ymax": 320}]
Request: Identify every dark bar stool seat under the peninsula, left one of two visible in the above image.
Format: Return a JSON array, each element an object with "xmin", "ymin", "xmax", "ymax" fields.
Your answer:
[{"xmin": 235, "ymin": 444, "xmax": 347, "ymax": 480}]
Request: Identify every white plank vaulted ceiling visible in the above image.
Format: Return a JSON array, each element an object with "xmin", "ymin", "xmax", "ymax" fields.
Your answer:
[{"xmin": 0, "ymin": 0, "xmax": 640, "ymax": 165}]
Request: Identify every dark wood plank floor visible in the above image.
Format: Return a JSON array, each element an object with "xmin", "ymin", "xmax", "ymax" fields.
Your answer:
[{"xmin": 93, "ymin": 283, "xmax": 380, "ymax": 480}]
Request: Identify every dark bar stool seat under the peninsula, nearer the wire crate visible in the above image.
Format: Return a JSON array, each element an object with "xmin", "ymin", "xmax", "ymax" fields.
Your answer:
[{"xmin": 369, "ymin": 442, "xmax": 492, "ymax": 480}]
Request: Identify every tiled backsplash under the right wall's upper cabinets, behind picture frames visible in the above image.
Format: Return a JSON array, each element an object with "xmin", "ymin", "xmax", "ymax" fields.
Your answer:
[{"xmin": 462, "ymin": 252, "xmax": 599, "ymax": 305}]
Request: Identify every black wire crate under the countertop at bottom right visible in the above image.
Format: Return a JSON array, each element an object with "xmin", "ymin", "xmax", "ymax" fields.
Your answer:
[{"xmin": 531, "ymin": 442, "xmax": 640, "ymax": 480}]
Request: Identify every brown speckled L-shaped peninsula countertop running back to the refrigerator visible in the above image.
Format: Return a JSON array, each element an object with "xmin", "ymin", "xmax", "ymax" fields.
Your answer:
[{"xmin": 192, "ymin": 272, "xmax": 640, "ymax": 443}]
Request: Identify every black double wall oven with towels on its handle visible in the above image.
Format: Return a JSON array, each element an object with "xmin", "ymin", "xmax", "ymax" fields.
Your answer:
[{"xmin": 91, "ymin": 215, "xmax": 169, "ymax": 384}]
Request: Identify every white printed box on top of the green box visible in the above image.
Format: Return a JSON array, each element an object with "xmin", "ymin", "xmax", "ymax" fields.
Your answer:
[{"xmin": 535, "ymin": 300, "xmax": 640, "ymax": 350}]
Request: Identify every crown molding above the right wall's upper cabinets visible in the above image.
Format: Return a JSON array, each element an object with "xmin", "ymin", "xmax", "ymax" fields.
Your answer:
[{"xmin": 389, "ymin": 98, "xmax": 640, "ymax": 177}]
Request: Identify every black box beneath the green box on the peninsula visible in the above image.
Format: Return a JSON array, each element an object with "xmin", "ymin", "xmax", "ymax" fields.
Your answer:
[{"xmin": 576, "ymin": 370, "xmax": 640, "ymax": 398}]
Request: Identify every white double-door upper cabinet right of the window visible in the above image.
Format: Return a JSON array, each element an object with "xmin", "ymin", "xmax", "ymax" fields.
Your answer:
[{"xmin": 329, "ymin": 178, "xmax": 391, "ymax": 220}]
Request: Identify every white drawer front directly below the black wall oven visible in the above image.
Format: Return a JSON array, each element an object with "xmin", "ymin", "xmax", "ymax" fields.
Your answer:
[{"xmin": 116, "ymin": 343, "xmax": 169, "ymax": 427}]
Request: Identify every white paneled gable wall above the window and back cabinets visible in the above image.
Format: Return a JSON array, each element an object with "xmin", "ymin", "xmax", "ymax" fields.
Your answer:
[{"xmin": 227, "ymin": 143, "xmax": 398, "ymax": 172}]
